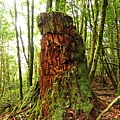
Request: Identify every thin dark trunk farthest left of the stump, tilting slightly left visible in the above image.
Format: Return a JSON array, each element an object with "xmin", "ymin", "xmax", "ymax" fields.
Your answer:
[{"xmin": 14, "ymin": 0, "xmax": 23, "ymax": 99}]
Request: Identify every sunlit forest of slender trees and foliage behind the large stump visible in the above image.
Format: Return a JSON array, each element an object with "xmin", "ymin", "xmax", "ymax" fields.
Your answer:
[{"xmin": 0, "ymin": 0, "xmax": 120, "ymax": 119}]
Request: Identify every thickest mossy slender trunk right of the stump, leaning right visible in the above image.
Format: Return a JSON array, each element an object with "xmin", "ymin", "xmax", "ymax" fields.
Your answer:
[{"xmin": 89, "ymin": 0, "xmax": 108, "ymax": 80}]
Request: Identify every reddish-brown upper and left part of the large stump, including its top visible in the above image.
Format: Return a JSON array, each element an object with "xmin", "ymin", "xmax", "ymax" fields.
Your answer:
[{"xmin": 38, "ymin": 12, "xmax": 88, "ymax": 117}]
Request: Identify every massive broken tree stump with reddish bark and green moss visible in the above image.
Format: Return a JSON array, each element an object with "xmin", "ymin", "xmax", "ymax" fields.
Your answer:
[{"xmin": 37, "ymin": 12, "xmax": 92, "ymax": 119}]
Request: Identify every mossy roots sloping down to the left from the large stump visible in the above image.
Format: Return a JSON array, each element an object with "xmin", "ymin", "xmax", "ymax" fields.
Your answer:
[{"xmin": 6, "ymin": 82, "xmax": 41, "ymax": 120}]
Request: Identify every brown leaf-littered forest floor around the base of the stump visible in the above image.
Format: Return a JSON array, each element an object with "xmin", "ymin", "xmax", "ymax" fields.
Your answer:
[{"xmin": 0, "ymin": 77, "xmax": 120, "ymax": 120}]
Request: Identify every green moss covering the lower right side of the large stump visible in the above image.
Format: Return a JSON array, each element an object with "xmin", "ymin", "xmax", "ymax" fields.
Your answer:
[{"xmin": 46, "ymin": 62, "xmax": 93, "ymax": 120}]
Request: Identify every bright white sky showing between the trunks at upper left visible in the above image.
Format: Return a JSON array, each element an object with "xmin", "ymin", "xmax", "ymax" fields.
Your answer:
[{"xmin": 0, "ymin": 0, "xmax": 46, "ymax": 70}]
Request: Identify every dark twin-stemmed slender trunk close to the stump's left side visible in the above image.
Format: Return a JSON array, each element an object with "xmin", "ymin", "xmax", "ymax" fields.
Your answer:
[{"xmin": 27, "ymin": 0, "xmax": 34, "ymax": 88}]
